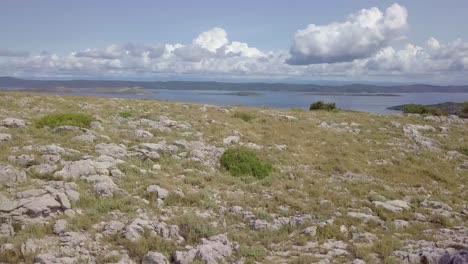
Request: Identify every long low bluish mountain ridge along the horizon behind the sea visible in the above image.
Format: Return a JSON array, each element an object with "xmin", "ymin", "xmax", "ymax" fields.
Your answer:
[{"xmin": 0, "ymin": 77, "xmax": 468, "ymax": 93}]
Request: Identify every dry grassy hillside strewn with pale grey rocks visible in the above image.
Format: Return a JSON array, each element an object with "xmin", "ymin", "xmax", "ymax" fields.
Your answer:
[{"xmin": 0, "ymin": 93, "xmax": 468, "ymax": 264}]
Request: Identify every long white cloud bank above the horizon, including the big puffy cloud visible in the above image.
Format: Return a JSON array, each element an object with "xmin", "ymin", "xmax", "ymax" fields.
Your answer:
[{"xmin": 0, "ymin": 4, "xmax": 468, "ymax": 83}]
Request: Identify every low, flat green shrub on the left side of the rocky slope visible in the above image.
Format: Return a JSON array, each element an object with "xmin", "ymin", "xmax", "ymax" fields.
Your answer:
[{"xmin": 36, "ymin": 113, "xmax": 95, "ymax": 128}]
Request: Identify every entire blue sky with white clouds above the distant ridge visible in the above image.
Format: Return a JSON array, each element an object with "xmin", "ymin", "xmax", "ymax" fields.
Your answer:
[{"xmin": 0, "ymin": 0, "xmax": 468, "ymax": 84}]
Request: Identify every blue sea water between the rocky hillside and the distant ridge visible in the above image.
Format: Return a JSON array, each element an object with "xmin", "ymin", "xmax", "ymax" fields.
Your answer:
[{"xmin": 2, "ymin": 89, "xmax": 468, "ymax": 114}]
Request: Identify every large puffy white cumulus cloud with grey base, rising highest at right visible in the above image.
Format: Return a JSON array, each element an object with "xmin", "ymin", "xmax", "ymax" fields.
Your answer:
[{"xmin": 287, "ymin": 4, "xmax": 408, "ymax": 65}]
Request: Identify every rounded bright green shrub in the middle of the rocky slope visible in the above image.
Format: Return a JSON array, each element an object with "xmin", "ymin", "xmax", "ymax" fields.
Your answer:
[{"xmin": 220, "ymin": 148, "xmax": 272, "ymax": 179}]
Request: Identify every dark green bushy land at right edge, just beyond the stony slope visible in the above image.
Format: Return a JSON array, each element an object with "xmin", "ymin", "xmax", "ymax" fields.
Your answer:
[{"xmin": 388, "ymin": 102, "xmax": 468, "ymax": 118}]
